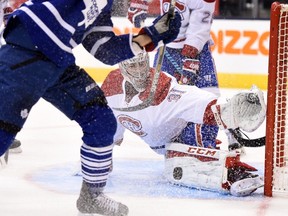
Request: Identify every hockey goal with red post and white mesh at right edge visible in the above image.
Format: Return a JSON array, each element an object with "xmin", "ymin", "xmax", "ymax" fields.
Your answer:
[{"xmin": 264, "ymin": 2, "xmax": 288, "ymax": 196}]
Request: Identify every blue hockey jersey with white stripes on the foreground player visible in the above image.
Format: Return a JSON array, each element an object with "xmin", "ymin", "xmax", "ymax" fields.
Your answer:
[{"xmin": 4, "ymin": 0, "xmax": 134, "ymax": 67}]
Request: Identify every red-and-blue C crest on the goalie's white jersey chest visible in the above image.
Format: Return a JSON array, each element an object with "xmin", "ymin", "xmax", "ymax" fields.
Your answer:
[{"xmin": 117, "ymin": 115, "xmax": 147, "ymax": 137}]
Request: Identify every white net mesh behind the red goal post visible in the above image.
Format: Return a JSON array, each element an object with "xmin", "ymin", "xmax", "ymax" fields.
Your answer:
[{"xmin": 273, "ymin": 5, "xmax": 288, "ymax": 193}]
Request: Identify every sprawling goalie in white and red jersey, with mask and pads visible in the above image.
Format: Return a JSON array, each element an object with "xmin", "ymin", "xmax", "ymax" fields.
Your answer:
[{"xmin": 101, "ymin": 53, "xmax": 266, "ymax": 196}]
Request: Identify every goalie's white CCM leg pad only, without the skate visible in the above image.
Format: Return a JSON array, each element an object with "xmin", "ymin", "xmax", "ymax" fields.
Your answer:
[{"xmin": 165, "ymin": 143, "xmax": 237, "ymax": 193}]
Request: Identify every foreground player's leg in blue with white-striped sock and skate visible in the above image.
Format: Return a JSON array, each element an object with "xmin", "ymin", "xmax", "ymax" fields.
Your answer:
[{"xmin": 43, "ymin": 65, "xmax": 128, "ymax": 216}]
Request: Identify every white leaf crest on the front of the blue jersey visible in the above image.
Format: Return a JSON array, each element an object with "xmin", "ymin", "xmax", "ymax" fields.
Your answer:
[{"xmin": 81, "ymin": 0, "xmax": 108, "ymax": 28}]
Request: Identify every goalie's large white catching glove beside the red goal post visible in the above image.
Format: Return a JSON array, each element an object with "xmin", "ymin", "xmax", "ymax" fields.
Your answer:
[{"xmin": 211, "ymin": 86, "xmax": 266, "ymax": 132}]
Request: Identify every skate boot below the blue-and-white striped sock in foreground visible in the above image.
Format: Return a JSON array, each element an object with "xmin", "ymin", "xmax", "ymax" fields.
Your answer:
[{"xmin": 77, "ymin": 181, "xmax": 129, "ymax": 216}]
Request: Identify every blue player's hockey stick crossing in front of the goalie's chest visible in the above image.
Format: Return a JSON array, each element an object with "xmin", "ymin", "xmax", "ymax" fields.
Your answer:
[{"xmin": 112, "ymin": 0, "xmax": 176, "ymax": 112}]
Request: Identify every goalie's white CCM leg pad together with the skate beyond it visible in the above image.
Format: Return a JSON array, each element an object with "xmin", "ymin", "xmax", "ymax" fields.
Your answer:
[{"xmin": 165, "ymin": 143, "xmax": 264, "ymax": 196}]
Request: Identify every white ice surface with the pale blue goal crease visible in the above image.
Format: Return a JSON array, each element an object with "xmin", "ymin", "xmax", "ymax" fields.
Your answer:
[{"xmin": 0, "ymin": 89, "xmax": 288, "ymax": 216}]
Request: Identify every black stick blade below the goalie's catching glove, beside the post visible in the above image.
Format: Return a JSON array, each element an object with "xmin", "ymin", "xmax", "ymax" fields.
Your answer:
[{"xmin": 229, "ymin": 129, "xmax": 266, "ymax": 147}]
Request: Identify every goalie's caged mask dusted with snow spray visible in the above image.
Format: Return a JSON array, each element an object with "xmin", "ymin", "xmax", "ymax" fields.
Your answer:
[{"xmin": 119, "ymin": 53, "xmax": 150, "ymax": 92}]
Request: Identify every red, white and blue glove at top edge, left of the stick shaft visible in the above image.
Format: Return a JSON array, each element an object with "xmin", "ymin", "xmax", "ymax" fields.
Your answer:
[{"xmin": 128, "ymin": 0, "xmax": 148, "ymax": 28}]
